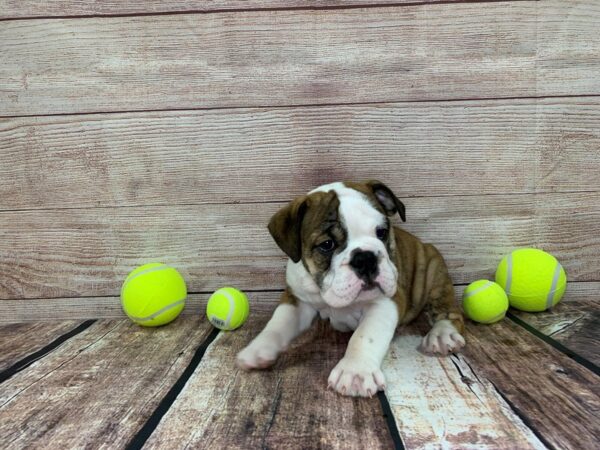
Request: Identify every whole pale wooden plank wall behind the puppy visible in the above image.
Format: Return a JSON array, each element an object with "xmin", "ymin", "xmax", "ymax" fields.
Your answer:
[{"xmin": 0, "ymin": 0, "xmax": 600, "ymax": 322}]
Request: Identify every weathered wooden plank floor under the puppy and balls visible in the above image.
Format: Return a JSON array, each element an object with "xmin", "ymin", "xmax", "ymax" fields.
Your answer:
[{"xmin": 0, "ymin": 297, "xmax": 600, "ymax": 449}]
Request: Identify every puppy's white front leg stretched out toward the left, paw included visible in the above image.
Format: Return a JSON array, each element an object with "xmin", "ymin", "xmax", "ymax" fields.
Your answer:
[{"xmin": 237, "ymin": 301, "xmax": 316, "ymax": 370}]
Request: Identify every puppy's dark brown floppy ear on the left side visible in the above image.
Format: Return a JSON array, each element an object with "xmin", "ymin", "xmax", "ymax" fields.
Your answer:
[{"xmin": 269, "ymin": 196, "xmax": 307, "ymax": 263}]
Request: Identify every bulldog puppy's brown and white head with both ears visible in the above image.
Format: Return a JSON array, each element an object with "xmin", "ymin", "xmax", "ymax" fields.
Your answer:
[{"xmin": 269, "ymin": 181, "xmax": 405, "ymax": 307}]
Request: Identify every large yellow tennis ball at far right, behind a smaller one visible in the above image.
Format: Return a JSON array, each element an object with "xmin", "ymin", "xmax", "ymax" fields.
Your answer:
[{"xmin": 496, "ymin": 248, "xmax": 567, "ymax": 312}]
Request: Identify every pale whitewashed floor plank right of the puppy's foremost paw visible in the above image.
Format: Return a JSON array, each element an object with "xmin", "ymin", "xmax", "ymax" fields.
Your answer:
[{"xmin": 383, "ymin": 332, "xmax": 546, "ymax": 450}]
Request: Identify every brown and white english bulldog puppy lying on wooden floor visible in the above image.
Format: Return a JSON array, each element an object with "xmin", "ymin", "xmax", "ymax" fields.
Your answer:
[{"xmin": 237, "ymin": 181, "xmax": 465, "ymax": 397}]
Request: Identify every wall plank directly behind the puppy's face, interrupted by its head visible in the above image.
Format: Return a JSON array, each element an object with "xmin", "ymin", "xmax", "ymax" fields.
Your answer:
[{"xmin": 0, "ymin": 193, "xmax": 600, "ymax": 299}]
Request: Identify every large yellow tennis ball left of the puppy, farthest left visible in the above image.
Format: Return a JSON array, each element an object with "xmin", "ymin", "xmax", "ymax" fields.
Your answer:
[{"xmin": 121, "ymin": 263, "xmax": 187, "ymax": 327}]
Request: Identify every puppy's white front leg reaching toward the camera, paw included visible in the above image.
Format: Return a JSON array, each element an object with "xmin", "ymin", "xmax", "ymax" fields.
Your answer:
[{"xmin": 328, "ymin": 298, "xmax": 398, "ymax": 397}]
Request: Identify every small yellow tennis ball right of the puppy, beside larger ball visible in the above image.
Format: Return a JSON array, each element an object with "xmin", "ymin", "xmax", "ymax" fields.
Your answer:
[{"xmin": 463, "ymin": 280, "xmax": 508, "ymax": 323}]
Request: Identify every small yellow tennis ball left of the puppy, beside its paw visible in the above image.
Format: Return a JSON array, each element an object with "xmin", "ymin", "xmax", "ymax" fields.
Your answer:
[{"xmin": 206, "ymin": 287, "xmax": 250, "ymax": 331}]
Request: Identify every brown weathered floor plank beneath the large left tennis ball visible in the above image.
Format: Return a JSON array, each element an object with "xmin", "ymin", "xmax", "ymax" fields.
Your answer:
[{"xmin": 0, "ymin": 318, "xmax": 212, "ymax": 449}]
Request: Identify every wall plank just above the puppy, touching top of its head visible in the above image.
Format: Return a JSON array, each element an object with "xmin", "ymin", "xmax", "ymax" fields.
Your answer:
[{"xmin": 0, "ymin": 97, "xmax": 600, "ymax": 210}]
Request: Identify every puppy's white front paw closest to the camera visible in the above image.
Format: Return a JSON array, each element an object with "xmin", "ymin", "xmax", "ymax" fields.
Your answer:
[{"xmin": 328, "ymin": 357, "xmax": 385, "ymax": 397}]
